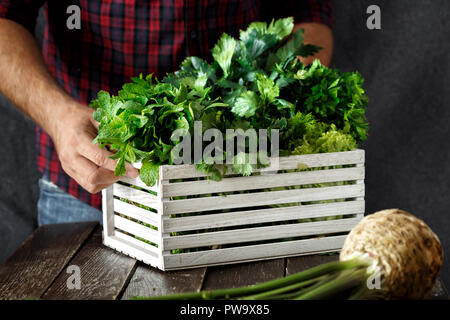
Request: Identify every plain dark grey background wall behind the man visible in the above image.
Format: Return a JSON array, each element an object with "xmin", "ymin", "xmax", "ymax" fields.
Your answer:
[{"xmin": 0, "ymin": 0, "xmax": 450, "ymax": 288}]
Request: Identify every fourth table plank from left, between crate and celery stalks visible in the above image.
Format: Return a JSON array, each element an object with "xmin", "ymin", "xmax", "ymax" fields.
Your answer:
[{"xmin": 202, "ymin": 259, "xmax": 284, "ymax": 290}]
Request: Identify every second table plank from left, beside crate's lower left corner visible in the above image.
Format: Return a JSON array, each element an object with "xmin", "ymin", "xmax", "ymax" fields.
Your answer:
[{"xmin": 43, "ymin": 229, "xmax": 137, "ymax": 300}]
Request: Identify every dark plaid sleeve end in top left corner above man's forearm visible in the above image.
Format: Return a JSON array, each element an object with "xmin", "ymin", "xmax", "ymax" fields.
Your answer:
[{"xmin": 0, "ymin": 0, "xmax": 45, "ymax": 33}]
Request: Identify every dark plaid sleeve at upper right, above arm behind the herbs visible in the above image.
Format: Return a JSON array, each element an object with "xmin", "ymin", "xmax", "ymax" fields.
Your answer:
[{"xmin": 262, "ymin": 0, "xmax": 333, "ymax": 28}]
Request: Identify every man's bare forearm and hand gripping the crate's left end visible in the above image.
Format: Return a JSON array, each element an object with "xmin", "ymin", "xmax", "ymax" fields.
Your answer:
[{"xmin": 0, "ymin": 19, "xmax": 139, "ymax": 193}]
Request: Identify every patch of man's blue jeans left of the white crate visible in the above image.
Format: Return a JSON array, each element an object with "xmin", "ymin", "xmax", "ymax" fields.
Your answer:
[{"xmin": 38, "ymin": 177, "xmax": 102, "ymax": 226}]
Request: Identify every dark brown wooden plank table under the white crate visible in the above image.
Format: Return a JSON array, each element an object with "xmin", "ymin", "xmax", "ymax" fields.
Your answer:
[{"xmin": 0, "ymin": 223, "xmax": 448, "ymax": 299}]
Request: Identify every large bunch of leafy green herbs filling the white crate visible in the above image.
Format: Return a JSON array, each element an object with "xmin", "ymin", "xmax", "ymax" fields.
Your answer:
[{"xmin": 91, "ymin": 18, "xmax": 369, "ymax": 185}]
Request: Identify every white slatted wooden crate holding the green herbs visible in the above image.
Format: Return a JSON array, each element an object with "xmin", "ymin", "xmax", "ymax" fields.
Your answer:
[{"xmin": 103, "ymin": 149, "xmax": 364, "ymax": 270}]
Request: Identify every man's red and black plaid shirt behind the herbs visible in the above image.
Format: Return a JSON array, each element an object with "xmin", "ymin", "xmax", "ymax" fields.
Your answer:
[{"xmin": 0, "ymin": 0, "xmax": 332, "ymax": 208}]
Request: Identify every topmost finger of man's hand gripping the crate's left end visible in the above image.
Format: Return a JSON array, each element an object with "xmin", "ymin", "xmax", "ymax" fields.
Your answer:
[{"xmin": 79, "ymin": 133, "xmax": 139, "ymax": 178}]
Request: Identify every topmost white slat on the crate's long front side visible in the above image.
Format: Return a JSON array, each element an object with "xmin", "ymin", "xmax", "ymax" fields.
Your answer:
[{"xmin": 160, "ymin": 149, "xmax": 364, "ymax": 180}]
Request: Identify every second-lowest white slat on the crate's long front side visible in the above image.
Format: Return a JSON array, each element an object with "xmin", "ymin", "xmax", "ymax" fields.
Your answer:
[{"xmin": 163, "ymin": 218, "xmax": 360, "ymax": 250}]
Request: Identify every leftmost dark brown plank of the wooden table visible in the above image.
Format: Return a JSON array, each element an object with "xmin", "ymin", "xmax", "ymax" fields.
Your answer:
[{"xmin": 0, "ymin": 222, "xmax": 98, "ymax": 299}]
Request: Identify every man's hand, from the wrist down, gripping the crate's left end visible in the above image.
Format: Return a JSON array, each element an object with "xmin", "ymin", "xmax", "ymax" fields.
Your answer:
[{"xmin": 49, "ymin": 103, "xmax": 139, "ymax": 193}]
